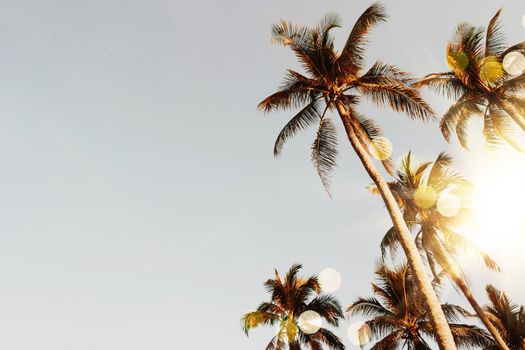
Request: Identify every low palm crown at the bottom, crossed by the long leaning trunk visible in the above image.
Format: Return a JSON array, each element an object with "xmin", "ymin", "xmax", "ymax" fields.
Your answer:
[{"xmin": 347, "ymin": 264, "xmax": 492, "ymax": 350}]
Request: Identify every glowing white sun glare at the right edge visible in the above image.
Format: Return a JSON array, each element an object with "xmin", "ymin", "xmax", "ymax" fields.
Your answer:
[{"xmin": 458, "ymin": 148, "xmax": 525, "ymax": 254}]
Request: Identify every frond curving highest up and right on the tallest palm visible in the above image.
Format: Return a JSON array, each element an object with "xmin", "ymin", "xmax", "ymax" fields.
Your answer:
[{"xmin": 337, "ymin": 3, "xmax": 387, "ymax": 76}]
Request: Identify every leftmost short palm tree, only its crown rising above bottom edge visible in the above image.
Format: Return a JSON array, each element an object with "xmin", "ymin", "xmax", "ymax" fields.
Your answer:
[{"xmin": 241, "ymin": 265, "xmax": 345, "ymax": 350}]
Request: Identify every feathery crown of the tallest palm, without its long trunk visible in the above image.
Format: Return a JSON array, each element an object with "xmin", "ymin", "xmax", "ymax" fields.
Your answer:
[{"xmin": 259, "ymin": 4, "xmax": 432, "ymax": 191}]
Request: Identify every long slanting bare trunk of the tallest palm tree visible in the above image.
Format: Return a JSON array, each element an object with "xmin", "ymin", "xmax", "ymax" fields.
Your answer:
[{"xmin": 337, "ymin": 102, "xmax": 456, "ymax": 350}]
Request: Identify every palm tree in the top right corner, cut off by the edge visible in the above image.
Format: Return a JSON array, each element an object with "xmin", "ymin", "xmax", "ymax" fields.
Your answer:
[{"xmin": 415, "ymin": 10, "xmax": 525, "ymax": 150}]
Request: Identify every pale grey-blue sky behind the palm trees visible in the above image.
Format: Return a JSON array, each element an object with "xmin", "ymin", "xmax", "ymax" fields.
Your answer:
[{"xmin": 0, "ymin": 0, "xmax": 525, "ymax": 350}]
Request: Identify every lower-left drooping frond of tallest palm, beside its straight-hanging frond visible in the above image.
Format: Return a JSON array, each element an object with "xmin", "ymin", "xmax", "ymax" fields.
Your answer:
[{"xmin": 273, "ymin": 100, "xmax": 326, "ymax": 157}]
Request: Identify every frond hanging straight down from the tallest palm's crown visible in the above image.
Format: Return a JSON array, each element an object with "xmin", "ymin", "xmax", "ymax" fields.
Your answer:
[{"xmin": 312, "ymin": 118, "xmax": 338, "ymax": 195}]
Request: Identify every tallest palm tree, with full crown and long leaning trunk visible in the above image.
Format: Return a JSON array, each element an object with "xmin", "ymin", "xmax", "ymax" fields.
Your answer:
[{"xmin": 259, "ymin": 4, "xmax": 455, "ymax": 349}]
